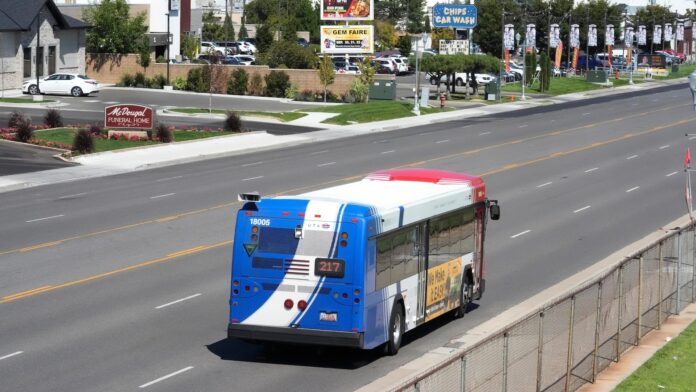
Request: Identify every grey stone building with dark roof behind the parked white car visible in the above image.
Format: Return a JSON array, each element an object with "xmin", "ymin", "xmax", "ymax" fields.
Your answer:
[{"xmin": 0, "ymin": 0, "xmax": 87, "ymax": 90}]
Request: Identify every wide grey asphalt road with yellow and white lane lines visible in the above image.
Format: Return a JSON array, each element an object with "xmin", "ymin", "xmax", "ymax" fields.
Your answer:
[{"xmin": 0, "ymin": 85, "xmax": 696, "ymax": 391}]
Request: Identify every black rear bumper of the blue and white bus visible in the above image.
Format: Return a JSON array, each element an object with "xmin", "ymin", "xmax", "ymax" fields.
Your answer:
[{"xmin": 227, "ymin": 324, "xmax": 364, "ymax": 348}]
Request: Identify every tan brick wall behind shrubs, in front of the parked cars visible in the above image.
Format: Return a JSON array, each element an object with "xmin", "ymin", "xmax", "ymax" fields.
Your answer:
[{"xmin": 86, "ymin": 54, "xmax": 394, "ymax": 95}]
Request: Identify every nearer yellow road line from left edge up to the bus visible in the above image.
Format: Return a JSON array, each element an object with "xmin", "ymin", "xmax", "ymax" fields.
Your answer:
[{"xmin": 0, "ymin": 240, "xmax": 232, "ymax": 304}]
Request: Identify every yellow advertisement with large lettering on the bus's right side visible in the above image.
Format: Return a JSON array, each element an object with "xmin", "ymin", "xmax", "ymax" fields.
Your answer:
[{"xmin": 425, "ymin": 257, "xmax": 463, "ymax": 321}]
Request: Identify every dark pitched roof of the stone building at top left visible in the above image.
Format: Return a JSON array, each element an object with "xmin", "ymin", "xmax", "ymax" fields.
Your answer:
[{"xmin": 0, "ymin": 0, "xmax": 88, "ymax": 31}]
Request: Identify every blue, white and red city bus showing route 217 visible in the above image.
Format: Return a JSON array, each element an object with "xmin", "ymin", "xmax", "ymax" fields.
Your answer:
[{"xmin": 227, "ymin": 169, "xmax": 500, "ymax": 355}]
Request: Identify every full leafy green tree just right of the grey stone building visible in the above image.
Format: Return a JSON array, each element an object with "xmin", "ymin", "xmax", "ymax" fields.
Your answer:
[{"xmin": 83, "ymin": 0, "xmax": 147, "ymax": 54}]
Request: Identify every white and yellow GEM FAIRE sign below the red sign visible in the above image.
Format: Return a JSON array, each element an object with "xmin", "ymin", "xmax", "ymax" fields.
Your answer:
[{"xmin": 321, "ymin": 25, "xmax": 375, "ymax": 54}]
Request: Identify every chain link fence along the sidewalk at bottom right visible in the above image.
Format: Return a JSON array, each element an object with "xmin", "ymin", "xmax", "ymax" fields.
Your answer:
[{"xmin": 396, "ymin": 220, "xmax": 696, "ymax": 392}]
